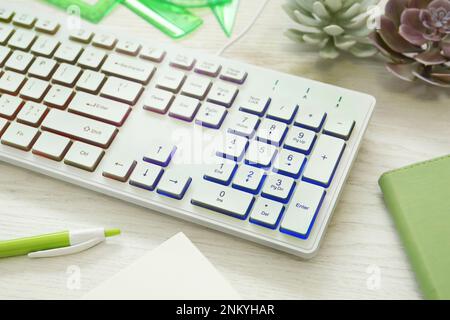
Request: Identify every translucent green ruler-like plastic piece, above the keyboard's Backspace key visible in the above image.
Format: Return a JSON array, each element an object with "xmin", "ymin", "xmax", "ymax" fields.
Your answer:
[{"xmin": 123, "ymin": 0, "xmax": 203, "ymax": 39}]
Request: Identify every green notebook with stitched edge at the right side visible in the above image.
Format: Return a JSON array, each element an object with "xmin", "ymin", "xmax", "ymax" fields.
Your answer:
[{"xmin": 379, "ymin": 155, "xmax": 450, "ymax": 299}]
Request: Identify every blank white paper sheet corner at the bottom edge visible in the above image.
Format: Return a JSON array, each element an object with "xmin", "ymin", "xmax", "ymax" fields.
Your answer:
[{"xmin": 83, "ymin": 233, "xmax": 240, "ymax": 300}]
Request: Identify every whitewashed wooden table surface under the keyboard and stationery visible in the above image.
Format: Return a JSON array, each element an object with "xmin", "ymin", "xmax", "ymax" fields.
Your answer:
[{"xmin": 0, "ymin": 0, "xmax": 450, "ymax": 299}]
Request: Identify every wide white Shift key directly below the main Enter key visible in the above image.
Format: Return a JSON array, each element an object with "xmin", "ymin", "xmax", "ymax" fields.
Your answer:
[{"xmin": 41, "ymin": 109, "xmax": 118, "ymax": 148}]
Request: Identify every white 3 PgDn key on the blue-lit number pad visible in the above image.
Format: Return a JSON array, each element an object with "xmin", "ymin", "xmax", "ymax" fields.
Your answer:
[{"xmin": 261, "ymin": 174, "xmax": 295, "ymax": 203}]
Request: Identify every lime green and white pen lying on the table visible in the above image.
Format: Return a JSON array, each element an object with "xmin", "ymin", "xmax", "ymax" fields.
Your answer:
[{"xmin": 0, "ymin": 228, "xmax": 120, "ymax": 258}]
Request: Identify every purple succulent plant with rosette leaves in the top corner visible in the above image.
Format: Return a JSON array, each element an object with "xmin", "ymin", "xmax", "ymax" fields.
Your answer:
[{"xmin": 371, "ymin": 0, "xmax": 450, "ymax": 88}]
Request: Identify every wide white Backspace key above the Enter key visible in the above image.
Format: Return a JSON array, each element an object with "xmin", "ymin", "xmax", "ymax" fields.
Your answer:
[{"xmin": 102, "ymin": 54, "xmax": 156, "ymax": 84}]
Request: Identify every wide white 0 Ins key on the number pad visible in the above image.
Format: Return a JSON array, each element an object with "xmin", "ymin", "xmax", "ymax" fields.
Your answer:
[{"xmin": 191, "ymin": 182, "xmax": 255, "ymax": 220}]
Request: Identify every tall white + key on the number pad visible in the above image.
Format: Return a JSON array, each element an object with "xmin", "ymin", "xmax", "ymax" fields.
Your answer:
[{"xmin": 302, "ymin": 135, "xmax": 345, "ymax": 188}]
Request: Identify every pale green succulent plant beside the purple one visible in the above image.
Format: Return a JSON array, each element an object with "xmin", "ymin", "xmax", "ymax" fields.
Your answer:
[{"xmin": 283, "ymin": 0, "xmax": 379, "ymax": 59}]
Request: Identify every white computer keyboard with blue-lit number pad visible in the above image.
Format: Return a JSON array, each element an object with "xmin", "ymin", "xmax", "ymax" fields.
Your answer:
[{"xmin": 0, "ymin": 4, "xmax": 375, "ymax": 258}]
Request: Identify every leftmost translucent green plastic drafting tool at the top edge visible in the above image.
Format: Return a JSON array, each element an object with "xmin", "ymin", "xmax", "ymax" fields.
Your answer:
[{"xmin": 45, "ymin": 0, "xmax": 121, "ymax": 23}]
